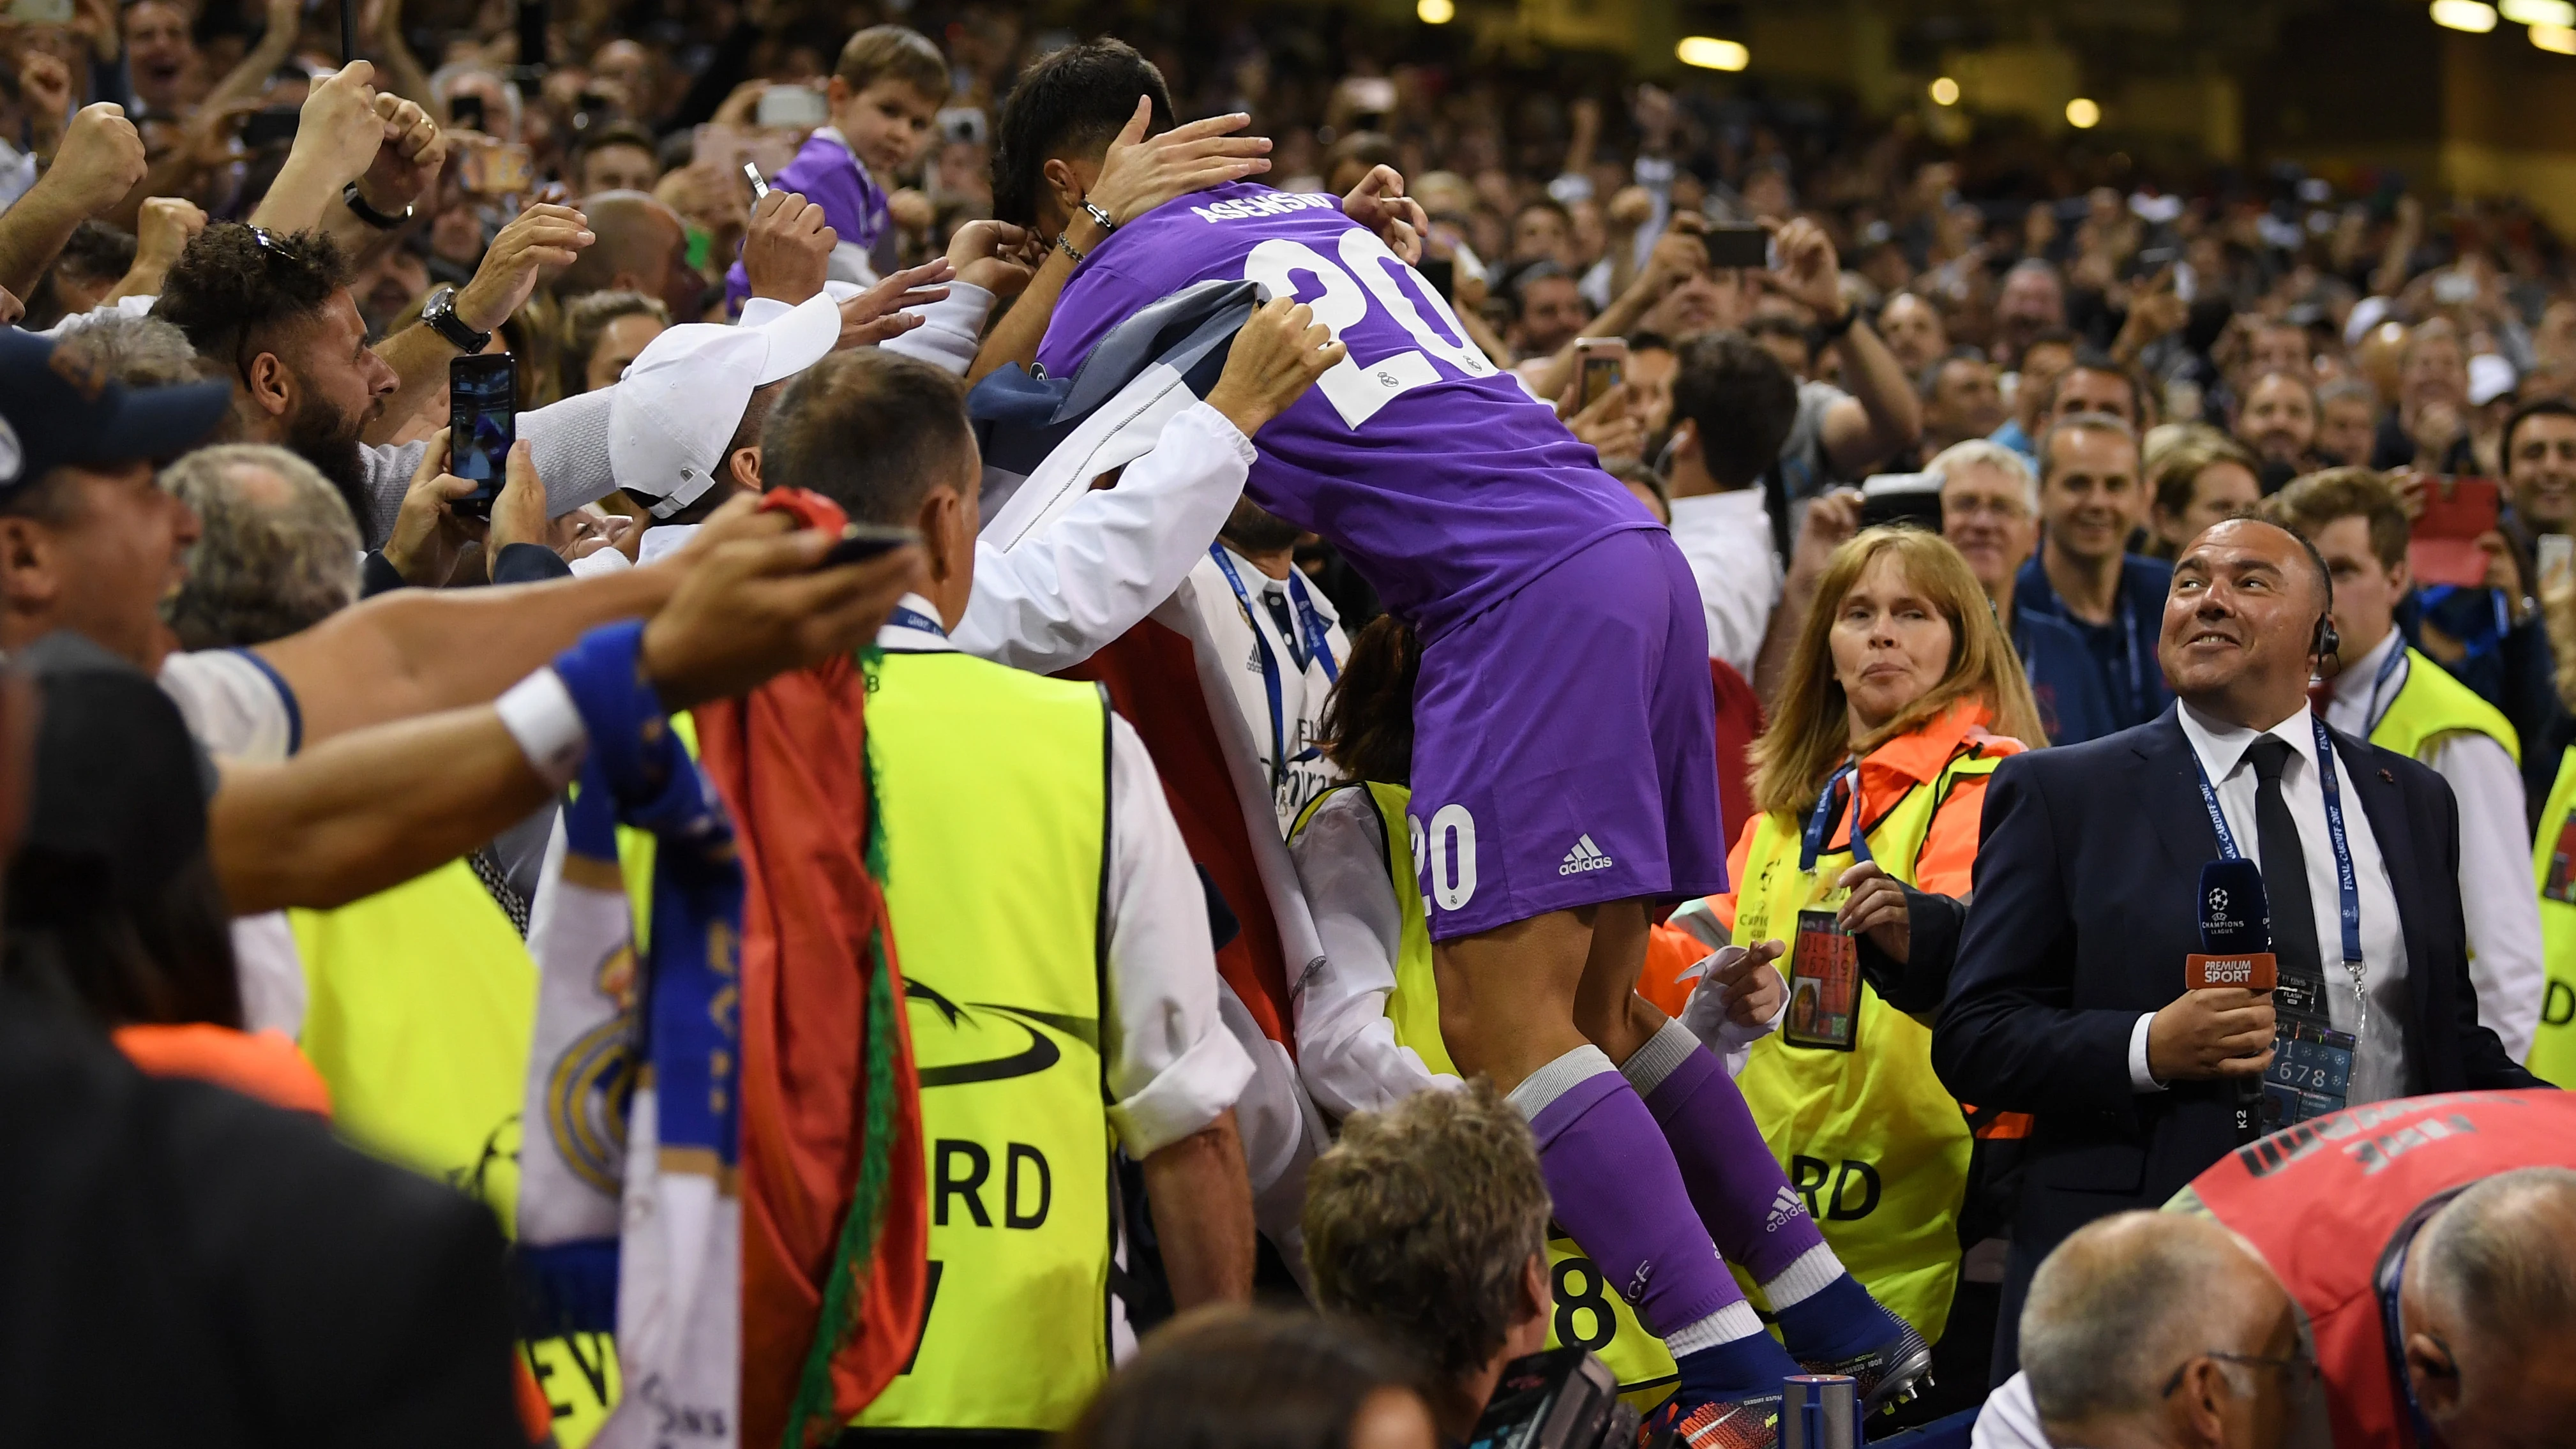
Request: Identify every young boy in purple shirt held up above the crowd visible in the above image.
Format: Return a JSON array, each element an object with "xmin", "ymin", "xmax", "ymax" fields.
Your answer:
[{"xmin": 724, "ymin": 26, "xmax": 948, "ymax": 312}]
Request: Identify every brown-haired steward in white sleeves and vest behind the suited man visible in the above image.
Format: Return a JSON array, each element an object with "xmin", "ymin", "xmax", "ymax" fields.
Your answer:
[{"xmin": 2270, "ymin": 469, "xmax": 2543, "ymax": 1060}]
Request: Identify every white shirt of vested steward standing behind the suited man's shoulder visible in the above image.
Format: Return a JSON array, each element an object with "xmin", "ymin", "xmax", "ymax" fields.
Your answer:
[{"xmin": 2326, "ymin": 628, "xmax": 2548, "ymax": 1060}]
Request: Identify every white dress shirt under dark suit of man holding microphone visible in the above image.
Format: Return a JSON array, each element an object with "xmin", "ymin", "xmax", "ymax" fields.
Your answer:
[{"xmin": 2128, "ymin": 705, "xmax": 2414, "ymax": 1107}]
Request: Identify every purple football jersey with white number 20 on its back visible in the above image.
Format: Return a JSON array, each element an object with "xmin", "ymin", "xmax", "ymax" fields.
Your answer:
[{"xmin": 1038, "ymin": 183, "xmax": 1653, "ymax": 636}]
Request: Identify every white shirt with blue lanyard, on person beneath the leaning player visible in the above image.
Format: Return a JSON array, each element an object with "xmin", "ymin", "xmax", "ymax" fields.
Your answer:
[{"xmin": 1190, "ymin": 543, "xmax": 1350, "ymax": 834}]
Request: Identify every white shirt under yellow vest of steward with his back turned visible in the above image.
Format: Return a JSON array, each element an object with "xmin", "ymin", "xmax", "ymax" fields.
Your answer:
[{"xmin": 876, "ymin": 594, "xmax": 1252, "ymax": 1160}]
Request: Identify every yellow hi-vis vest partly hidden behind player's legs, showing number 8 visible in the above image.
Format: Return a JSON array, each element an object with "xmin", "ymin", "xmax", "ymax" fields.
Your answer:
[{"xmin": 1298, "ymin": 780, "xmax": 1680, "ymax": 1413}]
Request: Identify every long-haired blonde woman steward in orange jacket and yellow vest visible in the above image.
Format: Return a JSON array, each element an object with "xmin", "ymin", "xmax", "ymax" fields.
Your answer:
[{"xmin": 1675, "ymin": 528, "xmax": 2045, "ymax": 1369}]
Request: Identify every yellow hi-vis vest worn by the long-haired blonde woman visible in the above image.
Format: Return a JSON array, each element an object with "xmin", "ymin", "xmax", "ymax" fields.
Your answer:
[{"xmin": 1731, "ymin": 744, "xmax": 2001, "ymax": 1341}]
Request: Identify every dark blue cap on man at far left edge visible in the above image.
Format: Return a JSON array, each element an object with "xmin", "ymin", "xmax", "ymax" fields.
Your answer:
[{"xmin": 0, "ymin": 327, "xmax": 232, "ymax": 497}]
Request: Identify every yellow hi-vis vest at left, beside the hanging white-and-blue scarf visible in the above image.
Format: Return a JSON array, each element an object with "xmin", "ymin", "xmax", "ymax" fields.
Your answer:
[{"xmin": 289, "ymin": 860, "xmax": 618, "ymax": 1449}]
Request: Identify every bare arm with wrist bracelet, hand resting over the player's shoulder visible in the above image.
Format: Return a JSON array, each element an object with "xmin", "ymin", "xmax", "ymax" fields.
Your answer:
[{"xmin": 966, "ymin": 95, "xmax": 1270, "ymax": 386}]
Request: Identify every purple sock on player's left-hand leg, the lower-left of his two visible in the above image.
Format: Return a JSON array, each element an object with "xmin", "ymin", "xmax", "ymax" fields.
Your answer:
[{"xmin": 1512, "ymin": 1047, "xmax": 1759, "ymax": 1344}]
